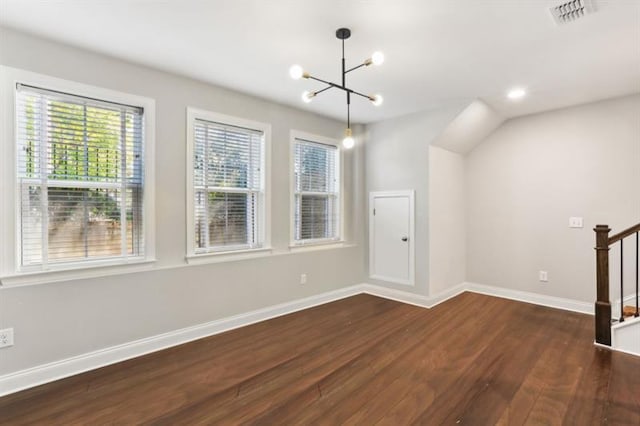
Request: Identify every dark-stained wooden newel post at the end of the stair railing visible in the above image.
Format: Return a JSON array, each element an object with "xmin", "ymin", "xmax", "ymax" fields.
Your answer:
[{"xmin": 593, "ymin": 225, "xmax": 611, "ymax": 346}]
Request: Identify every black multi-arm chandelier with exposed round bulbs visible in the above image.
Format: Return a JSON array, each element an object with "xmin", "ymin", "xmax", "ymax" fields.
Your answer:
[{"xmin": 289, "ymin": 28, "xmax": 384, "ymax": 149}]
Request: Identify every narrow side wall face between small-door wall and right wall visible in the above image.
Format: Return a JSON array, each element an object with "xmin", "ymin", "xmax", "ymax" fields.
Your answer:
[{"xmin": 429, "ymin": 146, "xmax": 467, "ymax": 295}]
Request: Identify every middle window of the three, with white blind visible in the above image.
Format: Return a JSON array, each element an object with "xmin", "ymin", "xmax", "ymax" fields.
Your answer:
[{"xmin": 187, "ymin": 108, "xmax": 269, "ymax": 255}]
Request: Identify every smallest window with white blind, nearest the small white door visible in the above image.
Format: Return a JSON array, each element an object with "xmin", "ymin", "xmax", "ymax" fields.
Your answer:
[{"xmin": 293, "ymin": 135, "xmax": 341, "ymax": 245}]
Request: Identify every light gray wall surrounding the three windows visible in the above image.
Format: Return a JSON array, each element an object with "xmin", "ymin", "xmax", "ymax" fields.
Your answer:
[{"xmin": 0, "ymin": 28, "xmax": 365, "ymax": 375}]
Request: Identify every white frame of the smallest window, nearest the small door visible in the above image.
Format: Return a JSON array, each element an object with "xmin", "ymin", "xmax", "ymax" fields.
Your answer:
[{"xmin": 289, "ymin": 130, "xmax": 345, "ymax": 251}]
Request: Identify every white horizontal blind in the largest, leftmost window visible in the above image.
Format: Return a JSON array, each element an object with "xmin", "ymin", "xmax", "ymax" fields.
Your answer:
[{"xmin": 16, "ymin": 84, "xmax": 144, "ymax": 268}]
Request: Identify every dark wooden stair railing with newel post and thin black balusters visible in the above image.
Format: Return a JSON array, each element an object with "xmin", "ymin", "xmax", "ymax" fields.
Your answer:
[{"xmin": 593, "ymin": 223, "xmax": 640, "ymax": 346}]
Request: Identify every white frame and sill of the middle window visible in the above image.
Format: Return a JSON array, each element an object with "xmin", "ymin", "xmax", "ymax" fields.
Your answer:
[{"xmin": 186, "ymin": 107, "xmax": 271, "ymax": 263}]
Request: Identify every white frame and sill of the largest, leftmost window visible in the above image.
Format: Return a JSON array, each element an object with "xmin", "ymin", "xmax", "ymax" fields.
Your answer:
[{"xmin": 0, "ymin": 66, "xmax": 155, "ymax": 286}]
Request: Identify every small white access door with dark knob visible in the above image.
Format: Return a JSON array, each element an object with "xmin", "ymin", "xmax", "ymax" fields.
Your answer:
[{"xmin": 369, "ymin": 191, "xmax": 414, "ymax": 285}]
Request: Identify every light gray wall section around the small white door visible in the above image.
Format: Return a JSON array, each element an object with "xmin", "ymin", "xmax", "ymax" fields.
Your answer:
[{"xmin": 365, "ymin": 103, "xmax": 465, "ymax": 295}]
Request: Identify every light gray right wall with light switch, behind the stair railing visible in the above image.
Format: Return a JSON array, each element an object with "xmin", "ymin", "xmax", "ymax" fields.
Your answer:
[{"xmin": 466, "ymin": 95, "xmax": 640, "ymax": 302}]
